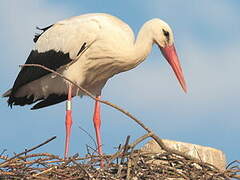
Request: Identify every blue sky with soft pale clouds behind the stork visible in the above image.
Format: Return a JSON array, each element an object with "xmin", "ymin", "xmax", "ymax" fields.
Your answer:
[{"xmin": 0, "ymin": 0, "xmax": 240, "ymax": 161}]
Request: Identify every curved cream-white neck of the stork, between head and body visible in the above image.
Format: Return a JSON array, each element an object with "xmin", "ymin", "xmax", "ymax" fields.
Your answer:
[{"xmin": 132, "ymin": 21, "xmax": 154, "ymax": 66}]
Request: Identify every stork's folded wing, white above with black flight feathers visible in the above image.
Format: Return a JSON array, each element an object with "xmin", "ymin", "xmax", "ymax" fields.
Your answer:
[{"xmin": 8, "ymin": 17, "xmax": 100, "ymax": 106}]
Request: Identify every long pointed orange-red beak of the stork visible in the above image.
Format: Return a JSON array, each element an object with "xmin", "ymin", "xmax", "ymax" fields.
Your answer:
[{"xmin": 160, "ymin": 44, "xmax": 187, "ymax": 93}]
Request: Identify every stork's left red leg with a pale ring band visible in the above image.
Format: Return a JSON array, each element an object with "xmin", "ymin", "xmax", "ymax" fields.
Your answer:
[{"xmin": 64, "ymin": 84, "xmax": 72, "ymax": 158}]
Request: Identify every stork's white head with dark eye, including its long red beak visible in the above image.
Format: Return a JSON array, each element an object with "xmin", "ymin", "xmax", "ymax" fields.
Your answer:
[{"xmin": 151, "ymin": 19, "xmax": 187, "ymax": 92}]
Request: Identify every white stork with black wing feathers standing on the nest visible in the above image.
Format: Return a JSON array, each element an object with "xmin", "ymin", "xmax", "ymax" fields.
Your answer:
[{"xmin": 3, "ymin": 13, "xmax": 187, "ymax": 160}]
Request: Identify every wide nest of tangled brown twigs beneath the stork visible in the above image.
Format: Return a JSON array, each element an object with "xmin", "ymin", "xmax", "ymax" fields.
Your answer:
[{"xmin": 0, "ymin": 138, "xmax": 240, "ymax": 180}]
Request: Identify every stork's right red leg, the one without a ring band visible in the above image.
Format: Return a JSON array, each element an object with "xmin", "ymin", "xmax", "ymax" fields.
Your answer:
[{"xmin": 93, "ymin": 96, "xmax": 103, "ymax": 167}]
